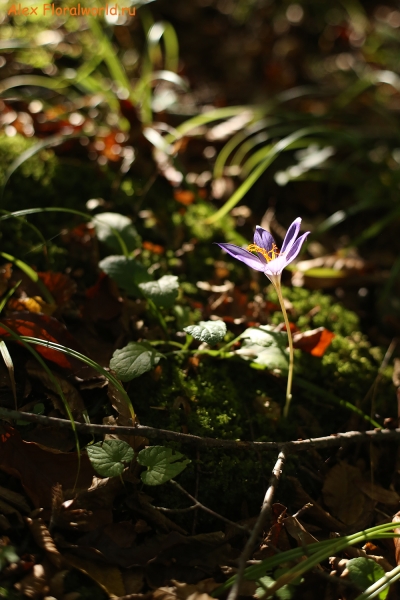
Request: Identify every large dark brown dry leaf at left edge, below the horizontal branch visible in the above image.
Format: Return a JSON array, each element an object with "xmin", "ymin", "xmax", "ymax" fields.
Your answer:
[{"xmin": 0, "ymin": 427, "xmax": 94, "ymax": 508}]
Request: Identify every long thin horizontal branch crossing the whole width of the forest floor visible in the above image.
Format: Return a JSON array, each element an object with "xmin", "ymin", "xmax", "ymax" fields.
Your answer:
[{"xmin": 0, "ymin": 407, "xmax": 400, "ymax": 452}]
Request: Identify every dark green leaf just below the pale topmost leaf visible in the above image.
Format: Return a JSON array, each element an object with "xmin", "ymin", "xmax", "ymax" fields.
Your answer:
[{"xmin": 99, "ymin": 255, "xmax": 151, "ymax": 296}]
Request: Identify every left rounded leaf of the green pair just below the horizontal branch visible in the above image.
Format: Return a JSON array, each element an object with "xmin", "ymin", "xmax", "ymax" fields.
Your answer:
[{"xmin": 86, "ymin": 440, "xmax": 134, "ymax": 477}]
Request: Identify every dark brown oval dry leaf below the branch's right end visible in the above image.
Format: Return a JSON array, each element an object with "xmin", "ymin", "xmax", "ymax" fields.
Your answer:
[{"xmin": 322, "ymin": 462, "xmax": 365, "ymax": 525}]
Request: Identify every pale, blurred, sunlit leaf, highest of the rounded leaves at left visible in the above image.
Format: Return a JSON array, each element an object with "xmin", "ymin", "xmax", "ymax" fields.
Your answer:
[{"xmin": 92, "ymin": 212, "xmax": 141, "ymax": 252}]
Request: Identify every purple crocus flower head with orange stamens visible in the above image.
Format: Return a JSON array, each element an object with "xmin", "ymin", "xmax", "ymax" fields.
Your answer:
[{"xmin": 218, "ymin": 217, "xmax": 310, "ymax": 286}]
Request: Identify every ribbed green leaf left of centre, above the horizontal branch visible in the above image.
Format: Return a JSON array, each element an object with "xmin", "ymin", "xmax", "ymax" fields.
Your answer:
[{"xmin": 110, "ymin": 342, "xmax": 164, "ymax": 381}]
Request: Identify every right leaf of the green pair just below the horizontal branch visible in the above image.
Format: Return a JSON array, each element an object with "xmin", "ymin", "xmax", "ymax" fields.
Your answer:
[{"xmin": 137, "ymin": 446, "xmax": 191, "ymax": 485}]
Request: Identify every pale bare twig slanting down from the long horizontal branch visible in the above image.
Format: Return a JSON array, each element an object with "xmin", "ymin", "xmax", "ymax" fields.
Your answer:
[{"xmin": 228, "ymin": 448, "xmax": 287, "ymax": 600}]
